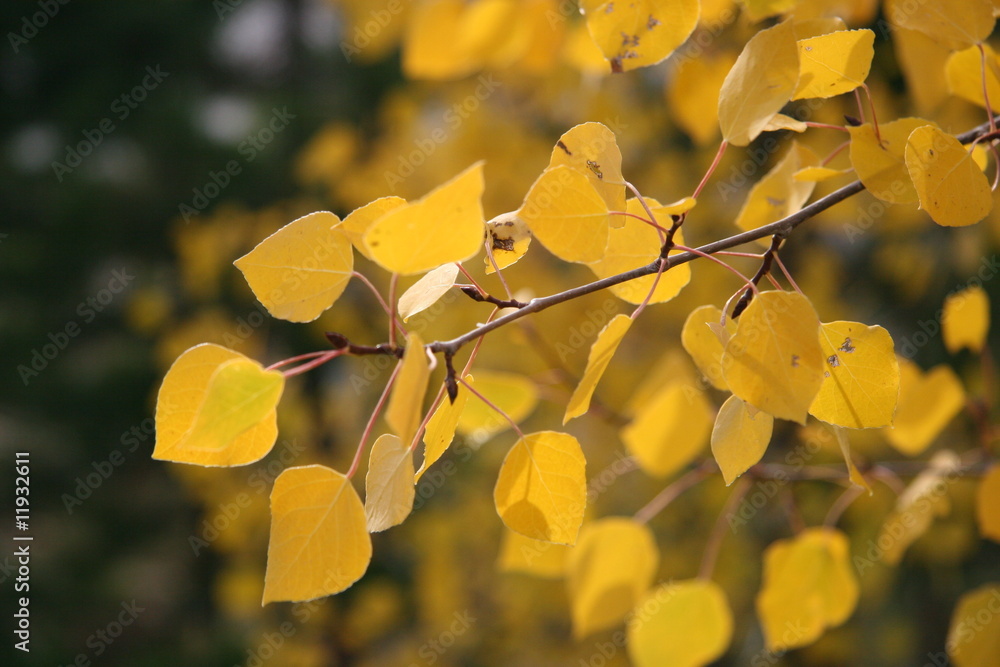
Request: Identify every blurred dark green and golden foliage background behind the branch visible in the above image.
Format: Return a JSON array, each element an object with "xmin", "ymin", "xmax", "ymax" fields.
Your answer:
[{"xmin": 0, "ymin": 0, "xmax": 1000, "ymax": 666}]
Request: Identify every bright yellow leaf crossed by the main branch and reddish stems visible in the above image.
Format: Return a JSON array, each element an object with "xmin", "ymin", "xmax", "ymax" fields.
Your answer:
[{"xmin": 587, "ymin": 197, "xmax": 697, "ymax": 304}]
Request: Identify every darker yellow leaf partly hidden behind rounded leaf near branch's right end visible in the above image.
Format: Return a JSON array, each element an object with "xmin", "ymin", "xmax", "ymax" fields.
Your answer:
[{"xmin": 847, "ymin": 118, "xmax": 928, "ymax": 204}]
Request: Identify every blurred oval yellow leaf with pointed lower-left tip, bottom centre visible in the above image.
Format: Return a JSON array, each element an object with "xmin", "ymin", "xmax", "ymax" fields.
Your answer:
[{"xmin": 567, "ymin": 517, "xmax": 660, "ymax": 639}]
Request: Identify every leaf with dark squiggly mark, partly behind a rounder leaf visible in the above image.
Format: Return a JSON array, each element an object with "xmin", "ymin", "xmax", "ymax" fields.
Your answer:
[{"xmin": 548, "ymin": 123, "xmax": 625, "ymax": 227}]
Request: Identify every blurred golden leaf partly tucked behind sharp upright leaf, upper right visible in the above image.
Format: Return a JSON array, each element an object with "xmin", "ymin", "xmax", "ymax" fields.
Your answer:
[{"xmin": 666, "ymin": 51, "xmax": 736, "ymax": 146}]
